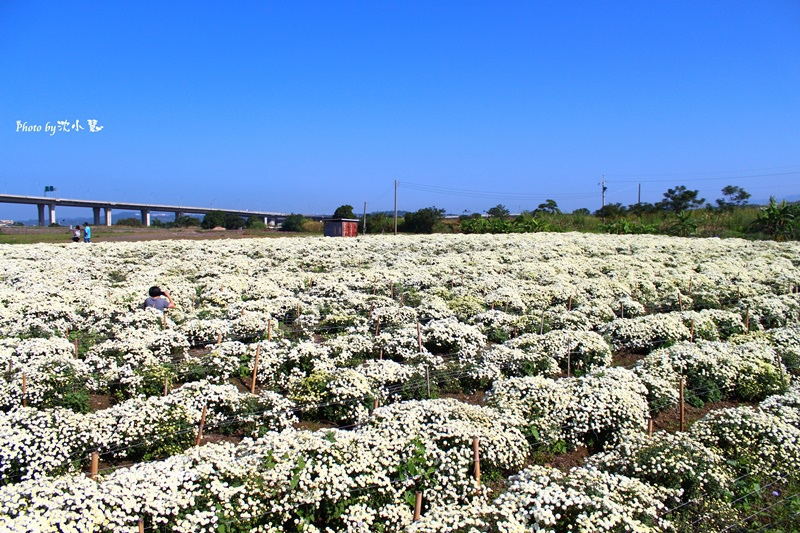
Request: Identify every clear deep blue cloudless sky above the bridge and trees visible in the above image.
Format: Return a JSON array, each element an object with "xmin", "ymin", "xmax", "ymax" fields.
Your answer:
[{"xmin": 0, "ymin": 0, "xmax": 800, "ymax": 219}]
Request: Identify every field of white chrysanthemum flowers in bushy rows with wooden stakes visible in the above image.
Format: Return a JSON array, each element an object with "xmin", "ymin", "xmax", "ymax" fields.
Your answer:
[{"xmin": 0, "ymin": 233, "xmax": 800, "ymax": 533}]
